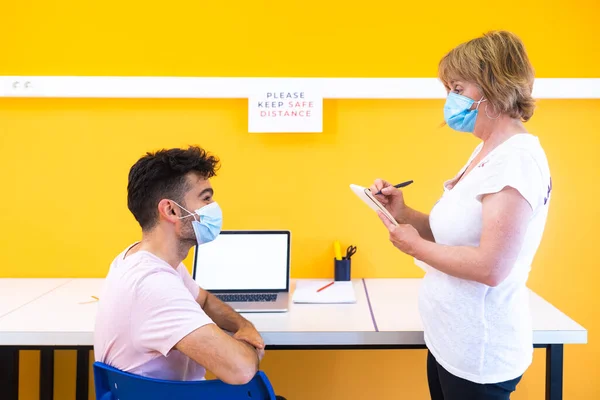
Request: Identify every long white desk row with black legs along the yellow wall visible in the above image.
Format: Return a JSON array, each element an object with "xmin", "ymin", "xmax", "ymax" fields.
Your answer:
[{"xmin": 0, "ymin": 279, "xmax": 587, "ymax": 400}]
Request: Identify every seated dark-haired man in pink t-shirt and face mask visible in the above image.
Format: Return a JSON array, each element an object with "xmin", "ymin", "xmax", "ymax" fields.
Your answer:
[{"xmin": 94, "ymin": 147, "xmax": 286, "ymax": 398}]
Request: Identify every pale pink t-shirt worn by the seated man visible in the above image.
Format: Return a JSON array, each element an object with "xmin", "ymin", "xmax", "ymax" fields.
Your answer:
[{"xmin": 94, "ymin": 246, "xmax": 213, "ymax": 381}]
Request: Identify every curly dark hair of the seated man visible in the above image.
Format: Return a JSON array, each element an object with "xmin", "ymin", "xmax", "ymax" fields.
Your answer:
[{"xmin": 127, "ymin": 146, "xmax": 219, "ymax": 231}]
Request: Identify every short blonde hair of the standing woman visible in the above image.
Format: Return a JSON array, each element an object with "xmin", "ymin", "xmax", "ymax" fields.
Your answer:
[{"xmin": 438, "ymin": 31, "xmax": 535, "ymax": 121}]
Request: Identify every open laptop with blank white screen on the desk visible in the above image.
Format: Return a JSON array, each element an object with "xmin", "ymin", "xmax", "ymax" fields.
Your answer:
[{"xmin": 192, "ymin": 230, "xmax": 291, "ymax": 312}]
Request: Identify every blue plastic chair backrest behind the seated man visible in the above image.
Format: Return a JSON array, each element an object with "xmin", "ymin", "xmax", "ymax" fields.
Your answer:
[{"xmin": 94, "ymin": 362, "xmax": 275, "ymax": 400}]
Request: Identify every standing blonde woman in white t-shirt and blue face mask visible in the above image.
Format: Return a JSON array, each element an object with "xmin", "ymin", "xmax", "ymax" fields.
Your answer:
[{"xmin": 371, "ymin": 32, "xmax": 552, "ymax": 400}]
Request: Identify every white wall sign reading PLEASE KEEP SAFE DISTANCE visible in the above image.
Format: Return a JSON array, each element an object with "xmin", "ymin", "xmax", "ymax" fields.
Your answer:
[{"xmin": 248, "ymin": 89, "xmax": 323, "ymax": 133}]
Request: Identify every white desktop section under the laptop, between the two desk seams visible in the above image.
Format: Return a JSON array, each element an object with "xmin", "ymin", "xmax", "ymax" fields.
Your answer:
[{"xmin": 0, "ymin": 279, "xmax": 375, "ymax": 346}]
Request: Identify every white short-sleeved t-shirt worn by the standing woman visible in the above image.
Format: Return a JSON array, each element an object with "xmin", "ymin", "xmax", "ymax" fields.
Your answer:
[{"xmin": 416, "ymin": 134, "xmax": 552, "ymax": 383}]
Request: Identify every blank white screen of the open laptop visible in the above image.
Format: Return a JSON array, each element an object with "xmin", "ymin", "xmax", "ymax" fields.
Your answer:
[{"xmin": 193, "ymin": 231, "xmax": 290, "ymax": 291}]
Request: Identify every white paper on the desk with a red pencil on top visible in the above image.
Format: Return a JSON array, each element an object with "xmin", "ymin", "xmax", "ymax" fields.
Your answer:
[{"xmin": 292, "ymin": 280, "xmax": 356, "ymax": 304}]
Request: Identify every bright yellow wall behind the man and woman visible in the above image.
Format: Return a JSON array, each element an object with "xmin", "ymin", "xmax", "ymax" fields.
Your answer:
[{"xmin": 0, "ymin": 0, "xmax": 600, "ymax": 400}]
